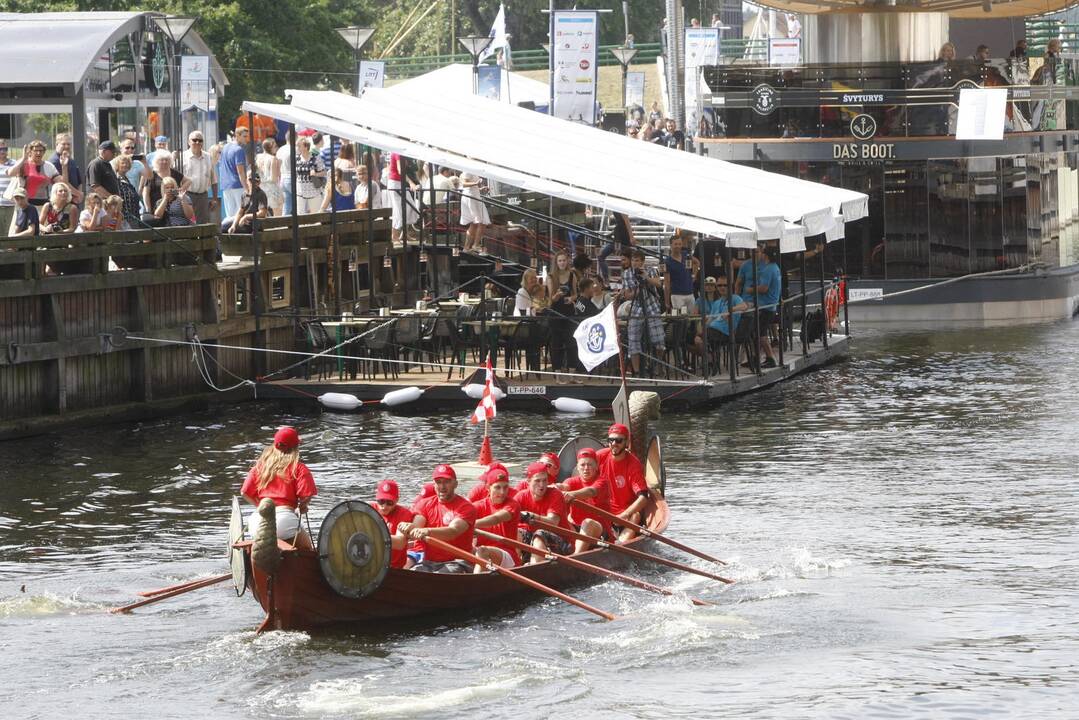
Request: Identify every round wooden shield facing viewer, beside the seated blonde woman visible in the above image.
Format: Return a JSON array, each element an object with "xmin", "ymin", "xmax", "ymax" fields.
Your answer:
[{"xmin": 318, "ymin": 500, "xmax": 390, "ymax": 598}]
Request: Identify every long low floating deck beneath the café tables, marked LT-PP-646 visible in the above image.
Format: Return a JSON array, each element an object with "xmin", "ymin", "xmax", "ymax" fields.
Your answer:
[{"xmin": 258, "ymin": 335, "xmax": 849, "ymax": 412}]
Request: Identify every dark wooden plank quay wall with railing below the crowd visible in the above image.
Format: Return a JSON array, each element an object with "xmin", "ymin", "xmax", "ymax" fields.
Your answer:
[{"xmin": 0, "ymin": 193, "xmax": 583, "ymax": 439}]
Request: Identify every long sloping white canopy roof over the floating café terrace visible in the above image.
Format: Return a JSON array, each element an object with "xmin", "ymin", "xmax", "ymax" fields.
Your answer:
[{"xmin": 244, "ymin": 89, "xmax": 868, "ymax": 252}]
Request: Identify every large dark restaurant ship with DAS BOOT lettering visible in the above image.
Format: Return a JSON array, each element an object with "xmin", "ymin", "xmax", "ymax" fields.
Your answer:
[{"xmin": 689, "ymin": 0, "xmax": 1079, "ymax": 327}]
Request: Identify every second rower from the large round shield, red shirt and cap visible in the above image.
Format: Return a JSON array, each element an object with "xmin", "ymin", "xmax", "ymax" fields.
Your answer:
[{"xmin": 398, "ymin": 464, "xmax": 476, "ymax": 572}]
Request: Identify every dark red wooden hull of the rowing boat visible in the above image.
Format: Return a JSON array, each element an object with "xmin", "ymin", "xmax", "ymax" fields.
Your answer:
[{"xmin": 245, "ymin": 502, "xmax": 669, "ymax": 630}]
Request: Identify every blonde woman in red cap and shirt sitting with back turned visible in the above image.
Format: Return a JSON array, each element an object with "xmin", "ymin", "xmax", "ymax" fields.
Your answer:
[{"xmin": 240, "ymin": 425, "xmax": 318, "ymax": 549}]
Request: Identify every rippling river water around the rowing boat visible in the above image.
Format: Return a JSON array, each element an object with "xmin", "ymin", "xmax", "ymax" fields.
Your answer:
[{"xmin": 0, "ymin": 323, "xmax": 1079, "ymax": 719}]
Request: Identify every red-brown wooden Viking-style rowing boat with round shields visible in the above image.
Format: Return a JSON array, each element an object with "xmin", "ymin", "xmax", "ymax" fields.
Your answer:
[{"xmin": 230, "ymin": 427, "xmax": 699, "ymax": 630}]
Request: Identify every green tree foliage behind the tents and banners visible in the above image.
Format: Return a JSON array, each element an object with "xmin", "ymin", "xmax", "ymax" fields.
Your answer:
[{"xmin": 0, "ymin": 0, "xmax": 664, "ymax": 130}]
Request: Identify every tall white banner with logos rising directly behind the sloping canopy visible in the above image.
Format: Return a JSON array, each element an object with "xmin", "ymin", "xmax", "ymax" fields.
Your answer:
[{"xmin": 551, "ymin": 10, "xmax": 599, "ymax": 125}]
